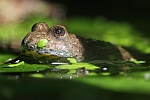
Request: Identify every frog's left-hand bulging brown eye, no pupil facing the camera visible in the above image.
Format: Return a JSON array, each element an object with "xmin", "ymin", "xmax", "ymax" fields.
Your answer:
[{"xmin": 32, "ymin": 22, "xmax": 49, "ymax": 32}]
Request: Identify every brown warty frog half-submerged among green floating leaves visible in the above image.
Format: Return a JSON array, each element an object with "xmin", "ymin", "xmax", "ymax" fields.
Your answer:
[{"xmin": 7, "ymin": 22, "xmax": 134, "ymax": 63}]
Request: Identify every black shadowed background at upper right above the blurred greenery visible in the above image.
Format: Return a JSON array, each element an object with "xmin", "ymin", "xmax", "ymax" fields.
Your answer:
[{"xmin": 46, "ymin": 0, "xmax": 150, "ymax": 37}]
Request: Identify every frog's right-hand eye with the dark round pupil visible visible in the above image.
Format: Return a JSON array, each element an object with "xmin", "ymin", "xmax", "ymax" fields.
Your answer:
[{"xmin": 50, "ymin": 25, "xmax": 66, "ymax": 38}]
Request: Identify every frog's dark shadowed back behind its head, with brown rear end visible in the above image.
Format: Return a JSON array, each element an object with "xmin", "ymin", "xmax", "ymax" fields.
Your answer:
[{"xmin": 78, "ymin": 37, "xmax": 133, "ymax": 61}]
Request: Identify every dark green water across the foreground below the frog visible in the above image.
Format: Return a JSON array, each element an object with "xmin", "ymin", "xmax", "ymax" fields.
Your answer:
[{"xmin": 0, "ymin": 58, "xmax": 150, "ymax": 100}]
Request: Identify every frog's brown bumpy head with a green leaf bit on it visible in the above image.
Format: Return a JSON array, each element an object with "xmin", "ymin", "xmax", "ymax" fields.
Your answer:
[{"xmin": 22, "ymin": 22, "xmax": 84, "ymax": 61}]
